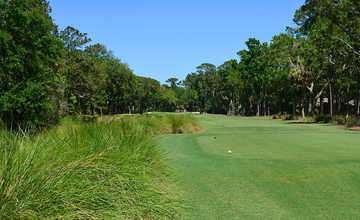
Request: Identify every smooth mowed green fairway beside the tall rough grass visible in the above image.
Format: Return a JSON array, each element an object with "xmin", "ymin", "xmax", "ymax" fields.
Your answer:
[{"xmin": 160, "ymin": 115, "xmax": 360, "ymax": 220}]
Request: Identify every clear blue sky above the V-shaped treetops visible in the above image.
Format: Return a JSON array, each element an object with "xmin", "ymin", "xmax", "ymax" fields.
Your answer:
[{"xmin": 50, "ymin": 0, "xmax": 304, "ymax": 83}]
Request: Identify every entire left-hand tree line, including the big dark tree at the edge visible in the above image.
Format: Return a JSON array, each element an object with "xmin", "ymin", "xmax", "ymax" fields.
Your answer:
[{"xmin": 0, "ymin": 0, "xmax": 176, "ymax": 128}]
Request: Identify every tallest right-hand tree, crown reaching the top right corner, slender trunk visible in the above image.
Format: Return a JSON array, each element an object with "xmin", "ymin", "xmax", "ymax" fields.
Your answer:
[{"xmin": 294, "ymin": 0, "xmax": 360, "ymax": 116}]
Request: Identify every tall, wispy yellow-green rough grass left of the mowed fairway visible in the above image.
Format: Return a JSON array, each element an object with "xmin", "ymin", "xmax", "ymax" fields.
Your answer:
[{"xmin": 0, "ymin": 115, "xmax": 198, "ymax": 219}]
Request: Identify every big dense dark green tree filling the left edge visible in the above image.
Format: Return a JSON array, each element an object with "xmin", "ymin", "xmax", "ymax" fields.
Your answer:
[{"xmin": 0, "ymin": 0, "xmax": 62, "ymax": 129}]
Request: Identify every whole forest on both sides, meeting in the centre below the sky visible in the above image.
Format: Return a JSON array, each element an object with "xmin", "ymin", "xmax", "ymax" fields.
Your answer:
[{"xmin": 0, "ymin": 0, "xmax": 360, "ymax": 130}]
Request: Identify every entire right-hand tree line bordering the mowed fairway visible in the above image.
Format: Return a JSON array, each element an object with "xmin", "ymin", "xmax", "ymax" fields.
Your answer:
[{"xmin": 181, "ymin": 0, "xmax": 360, "ymax": 117}]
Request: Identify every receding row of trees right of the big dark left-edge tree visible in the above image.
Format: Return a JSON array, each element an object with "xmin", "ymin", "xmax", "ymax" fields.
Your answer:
[{"xmin": 60, "ymin": 27, "xmax": 178, "ymax": 115}]
